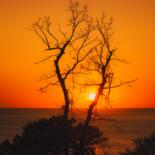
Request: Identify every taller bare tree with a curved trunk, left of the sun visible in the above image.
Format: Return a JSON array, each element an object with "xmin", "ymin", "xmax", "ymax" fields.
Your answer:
[{"xmin": 31, "ymin": 0, "xmax": 99, "ymax": 119}]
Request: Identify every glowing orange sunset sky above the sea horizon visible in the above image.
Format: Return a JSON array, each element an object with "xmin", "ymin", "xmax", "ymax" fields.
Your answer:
[{"xmin": 0, "ymin": 0, "xmax": 155, "ymax": 108}]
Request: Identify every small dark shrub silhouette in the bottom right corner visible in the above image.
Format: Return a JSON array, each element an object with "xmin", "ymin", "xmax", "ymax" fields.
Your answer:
[{"xmin": 121, "ymin": 132, "xmax": 155, "ymax": 155}]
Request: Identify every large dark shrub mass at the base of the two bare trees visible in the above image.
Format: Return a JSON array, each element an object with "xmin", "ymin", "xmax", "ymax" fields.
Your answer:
[{"xmin": 0, "ymin": 116, "xmax": 107, "ymax": 155}]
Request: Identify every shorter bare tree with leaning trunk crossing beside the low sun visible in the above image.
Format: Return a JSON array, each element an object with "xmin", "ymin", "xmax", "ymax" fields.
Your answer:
[{"xmin": 82, "ymin": 15, "xmax": 136, "ymax": 126}]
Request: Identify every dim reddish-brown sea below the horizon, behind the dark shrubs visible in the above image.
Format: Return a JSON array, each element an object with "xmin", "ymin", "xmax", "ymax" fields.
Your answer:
[{"xmin": 0, "ymin": 108, "xmax": 155, "ymax": 155}]
